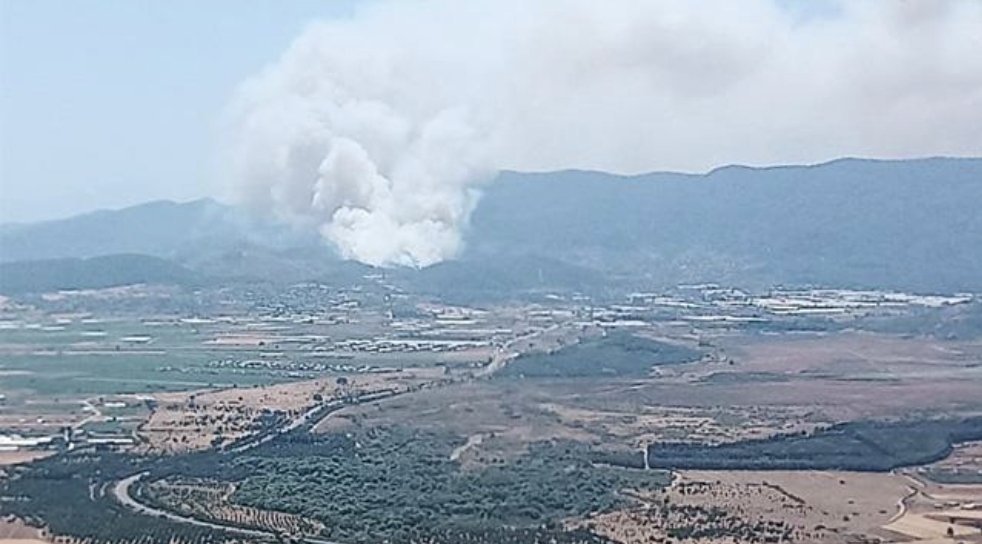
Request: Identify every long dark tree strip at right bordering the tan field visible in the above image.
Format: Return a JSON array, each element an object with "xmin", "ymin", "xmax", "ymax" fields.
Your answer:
[{"xmin": 601, "ymin": 417, "xmax": 982, "ymax": 472}]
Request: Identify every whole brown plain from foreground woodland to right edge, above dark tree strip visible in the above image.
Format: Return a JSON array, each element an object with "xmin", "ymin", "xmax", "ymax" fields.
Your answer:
[{"xmin": 318, "ymin": 334, "xmax": 982, "ymax": 464}]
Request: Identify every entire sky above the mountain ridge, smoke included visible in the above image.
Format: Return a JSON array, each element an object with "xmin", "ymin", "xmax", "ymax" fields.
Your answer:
[{"xmin": 0, "ymin": 0, "xmax": 982, "ymax": 225}]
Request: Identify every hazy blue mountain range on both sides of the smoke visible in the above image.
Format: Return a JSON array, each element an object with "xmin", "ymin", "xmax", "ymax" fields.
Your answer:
[{"xmin": 0, "ymin": 159, "xmax": 982, "ymax": 293}]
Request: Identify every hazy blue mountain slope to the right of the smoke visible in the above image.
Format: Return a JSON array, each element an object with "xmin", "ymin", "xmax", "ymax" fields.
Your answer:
[{"xmin": 469, "ymin": 159, "xmax": 982, "ymax": 290}]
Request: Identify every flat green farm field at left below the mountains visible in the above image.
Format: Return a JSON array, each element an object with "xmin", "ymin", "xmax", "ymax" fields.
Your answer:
[{"xmin": 0, "ymin": 321, "xmax": 308, "ymax": 398}]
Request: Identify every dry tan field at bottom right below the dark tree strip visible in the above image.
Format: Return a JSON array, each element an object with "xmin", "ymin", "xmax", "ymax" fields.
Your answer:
[{"xmin": 570, "ymin": 471, "xmax": 982, "ymax": 544}]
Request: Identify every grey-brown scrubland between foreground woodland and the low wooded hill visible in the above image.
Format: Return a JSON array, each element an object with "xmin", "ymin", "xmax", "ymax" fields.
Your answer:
[{"xmin": 317, "ymin": 380, "xmax": 818, "ymax": 466}]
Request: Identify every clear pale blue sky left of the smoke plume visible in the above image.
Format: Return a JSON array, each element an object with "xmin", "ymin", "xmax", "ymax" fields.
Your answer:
[{"xmin": 0, "ymin": 0, "xmax": 351, "ymax": 223}]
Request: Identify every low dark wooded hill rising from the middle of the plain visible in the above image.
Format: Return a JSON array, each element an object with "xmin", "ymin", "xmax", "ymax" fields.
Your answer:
[{"xmin": 499, "ymin": 332, "xmax": 702, "ymax": 378}]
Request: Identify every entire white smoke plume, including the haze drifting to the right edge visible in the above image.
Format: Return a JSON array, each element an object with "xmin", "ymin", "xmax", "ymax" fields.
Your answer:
[{"xmin": 228, "ymin": 0, "xmax": 982, "ymax": 266}]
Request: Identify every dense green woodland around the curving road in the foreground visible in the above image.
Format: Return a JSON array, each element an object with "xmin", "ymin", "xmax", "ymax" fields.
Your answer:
[{"xmin": 0, "ymin": 427, "xmax": 669, "ymax": 544}]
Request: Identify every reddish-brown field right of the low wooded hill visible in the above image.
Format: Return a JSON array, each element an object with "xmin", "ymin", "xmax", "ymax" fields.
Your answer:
[{"xmin": 576, "ymin": 333, "xmax": 982, "ymax": 421}]
